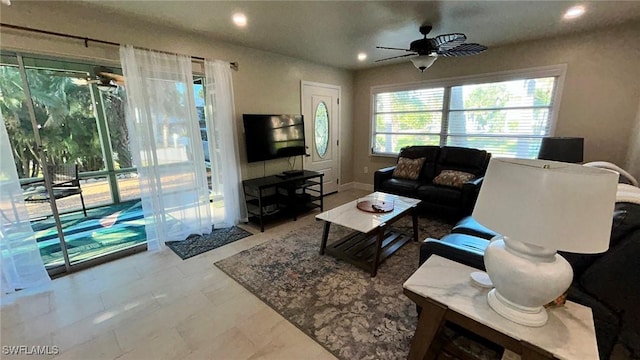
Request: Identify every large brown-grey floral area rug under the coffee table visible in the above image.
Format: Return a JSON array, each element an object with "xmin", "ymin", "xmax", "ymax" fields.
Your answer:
[{"xmin": 215, "ymin": 217, "xmax": 458, "ymax": 359}]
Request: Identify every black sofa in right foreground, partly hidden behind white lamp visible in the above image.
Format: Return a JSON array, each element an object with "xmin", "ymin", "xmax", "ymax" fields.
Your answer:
[{"xmin": 420, "ymin": 202, "xmax": 640, "ymax": 359}]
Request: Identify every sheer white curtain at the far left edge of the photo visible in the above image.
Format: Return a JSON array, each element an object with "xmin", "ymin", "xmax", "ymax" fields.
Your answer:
[{"xmin": 0, "ymin": 114, "xmax": 51, "ymax": 295}]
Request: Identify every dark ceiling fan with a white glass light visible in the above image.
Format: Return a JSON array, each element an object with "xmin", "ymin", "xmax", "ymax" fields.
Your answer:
[{"xmin": 375, "ymin": 25, "xmax": 487, "ymax": 72}]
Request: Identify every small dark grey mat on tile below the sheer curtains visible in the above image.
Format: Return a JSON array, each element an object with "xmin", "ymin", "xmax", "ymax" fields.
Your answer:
[{"xmin": 165, "ymin": 226, "xmax": 252, "ymax": 260}]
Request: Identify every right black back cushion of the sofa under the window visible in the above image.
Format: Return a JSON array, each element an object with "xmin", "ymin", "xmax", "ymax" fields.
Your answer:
[{"xmin": 435, "ymin": 146, "xmax": 489, "ymax": 176}]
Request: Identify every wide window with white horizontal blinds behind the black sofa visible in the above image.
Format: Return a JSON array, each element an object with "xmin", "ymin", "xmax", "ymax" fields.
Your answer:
[{"xmin": 371, "ymin": 66, "xmax": 565, "ymax": 158}]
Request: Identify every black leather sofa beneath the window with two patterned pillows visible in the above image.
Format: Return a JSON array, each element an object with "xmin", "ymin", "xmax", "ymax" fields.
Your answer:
[{"xmin": 373, "ymin": 146, "xmax": 491, "ymax": 218}]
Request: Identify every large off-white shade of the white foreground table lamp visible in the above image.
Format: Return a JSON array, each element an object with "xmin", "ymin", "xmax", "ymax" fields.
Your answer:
[{"xmin": 473, "ymin": 158, "xmax": 618, "ymax": 253}]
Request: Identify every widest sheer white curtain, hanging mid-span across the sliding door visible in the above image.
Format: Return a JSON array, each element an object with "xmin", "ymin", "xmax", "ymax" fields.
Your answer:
[{"xmin": 120, "ymin": 45, "xmax": 212, "ymax": 250}]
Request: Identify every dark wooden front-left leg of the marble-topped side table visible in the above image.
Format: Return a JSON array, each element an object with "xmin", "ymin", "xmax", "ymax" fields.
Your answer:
[{"xmin": 408, "ymin": 301, "xmax": 447, "ymax": 360}]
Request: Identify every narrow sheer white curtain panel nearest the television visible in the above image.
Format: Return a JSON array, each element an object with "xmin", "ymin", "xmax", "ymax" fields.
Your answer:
[{"xmin": 204, "ymin": 60, "xmax": 247, "ymax": 228}]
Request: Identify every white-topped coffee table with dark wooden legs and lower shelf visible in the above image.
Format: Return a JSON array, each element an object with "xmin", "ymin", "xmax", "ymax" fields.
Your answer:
[{"xmin": 316, "ymin": 192, "xmax": 420, "ymax": 277}]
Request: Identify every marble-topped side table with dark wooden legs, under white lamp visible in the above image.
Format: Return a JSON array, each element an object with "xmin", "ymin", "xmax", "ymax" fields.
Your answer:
[{"xmin": 403, "ymin": 255, "xmax": 598, "ymax": 360}]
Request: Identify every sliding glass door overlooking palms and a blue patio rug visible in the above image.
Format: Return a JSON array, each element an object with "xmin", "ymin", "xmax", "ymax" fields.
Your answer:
[{"xmin": 0, "ymin": 53, "xmax": 146, "ymax": 273}]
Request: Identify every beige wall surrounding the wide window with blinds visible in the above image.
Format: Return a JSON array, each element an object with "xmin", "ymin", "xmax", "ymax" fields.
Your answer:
[{"xmin": 353, "ymin": 24, "xmax": 640, "ymax": 184}]
